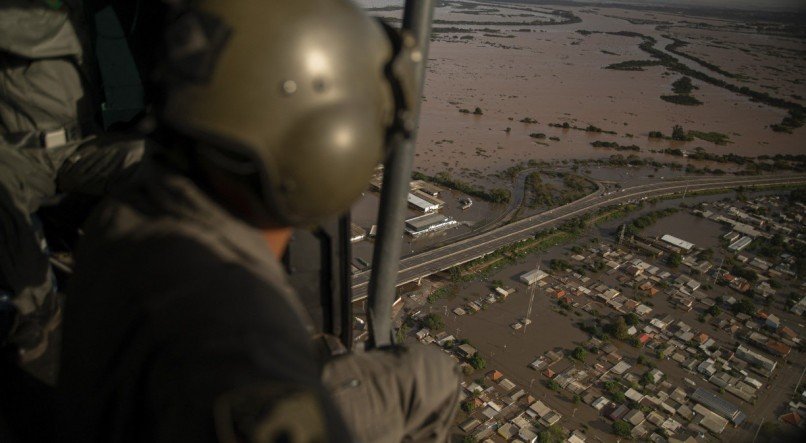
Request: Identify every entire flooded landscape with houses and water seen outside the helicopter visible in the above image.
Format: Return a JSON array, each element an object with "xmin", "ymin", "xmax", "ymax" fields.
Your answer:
[{"xmin": 353, "ymin": 0, "xmax": 806, "ymax": 442}]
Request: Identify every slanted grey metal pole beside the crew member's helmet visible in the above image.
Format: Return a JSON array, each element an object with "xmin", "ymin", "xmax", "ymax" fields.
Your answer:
[{"xmin": 367, "ymin": 0, "xmax": 434, "ymax": 349}]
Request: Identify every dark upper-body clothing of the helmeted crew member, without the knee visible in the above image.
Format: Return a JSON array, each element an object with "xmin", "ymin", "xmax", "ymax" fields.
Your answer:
[{"xmin": 59, "ymin": 166, "xmax": 348, "ymax": 442}]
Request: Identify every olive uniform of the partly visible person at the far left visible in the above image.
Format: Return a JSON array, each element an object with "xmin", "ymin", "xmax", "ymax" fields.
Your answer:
[{"xmin": 0, "ymin": 0, "xmax": 145, "ymax": 332}]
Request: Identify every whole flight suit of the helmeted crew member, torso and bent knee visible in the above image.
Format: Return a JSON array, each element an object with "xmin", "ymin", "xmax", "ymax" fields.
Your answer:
[{"xmin": 59, "ymin": 162, "xmax": 459, "ymax": 442}]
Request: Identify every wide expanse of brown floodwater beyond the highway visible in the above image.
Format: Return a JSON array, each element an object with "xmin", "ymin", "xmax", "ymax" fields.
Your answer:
[{"xmin": 362, "ymin": 1, "xmax": 806, "ymax": 186}]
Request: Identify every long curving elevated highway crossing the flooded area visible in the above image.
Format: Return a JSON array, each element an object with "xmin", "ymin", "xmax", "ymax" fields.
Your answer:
[{"xmin": 352, "ymin": 175, "xmax": 806, "ymax": 301}]
